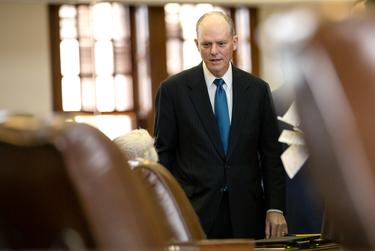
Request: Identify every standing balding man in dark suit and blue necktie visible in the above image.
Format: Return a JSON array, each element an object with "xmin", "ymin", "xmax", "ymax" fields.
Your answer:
[{"xmin": 155, "ymin": 12, "xmax": 287, "ymax": 238}]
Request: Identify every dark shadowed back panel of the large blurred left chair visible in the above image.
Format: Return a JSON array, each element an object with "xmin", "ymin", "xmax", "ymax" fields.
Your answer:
[{"xmin": 0, "ymin": 120, "xmax": 96, "ymax": 249}]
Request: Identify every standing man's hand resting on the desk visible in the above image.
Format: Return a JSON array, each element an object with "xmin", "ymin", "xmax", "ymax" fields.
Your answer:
[{"xmin": 266, "ymin": 212, "xmax": 288, "ymax": 239}]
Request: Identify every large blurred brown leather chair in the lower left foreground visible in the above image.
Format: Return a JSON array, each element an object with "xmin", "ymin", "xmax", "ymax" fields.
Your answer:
[{"xmin": 0, "ymin": 116, "xmax": 170, "ymax": 251}]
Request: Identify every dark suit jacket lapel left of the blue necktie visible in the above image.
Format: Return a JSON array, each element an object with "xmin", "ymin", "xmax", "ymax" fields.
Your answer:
[{"xmin": 188, "ymin": 64, "xmax": 224, "ymax": 158}]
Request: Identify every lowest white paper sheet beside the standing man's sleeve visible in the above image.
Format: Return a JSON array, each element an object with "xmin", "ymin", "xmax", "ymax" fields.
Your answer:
[{"xmin": 281, "ymin": 145, "xmax": 309, "ymax": 179}]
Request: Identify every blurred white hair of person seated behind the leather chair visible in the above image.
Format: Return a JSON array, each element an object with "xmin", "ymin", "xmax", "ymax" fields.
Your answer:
[{"xmin": 113, "ymin": 129, "xmax": 158, "ymax": 161}]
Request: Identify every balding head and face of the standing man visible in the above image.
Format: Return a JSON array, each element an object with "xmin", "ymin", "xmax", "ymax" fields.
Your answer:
[{"xmin": 195, "ymin": 15, "xmax": 237, "ymax": 77}]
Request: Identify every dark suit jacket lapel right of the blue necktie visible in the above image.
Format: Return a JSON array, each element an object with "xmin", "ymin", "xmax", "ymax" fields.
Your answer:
[{"xmin": 227, "ymin": 65, "xmax": 249, "ymax": 159}]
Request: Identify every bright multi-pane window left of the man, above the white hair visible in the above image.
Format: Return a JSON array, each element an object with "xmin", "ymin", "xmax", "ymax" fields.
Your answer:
[{"xmin": 50, "ymin": 2, "xmax": 151, "ymax": 138}]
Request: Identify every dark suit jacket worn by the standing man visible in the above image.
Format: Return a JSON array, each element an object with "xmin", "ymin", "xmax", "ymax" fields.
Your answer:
[{"xmin": 155, "ymin": 64, "xmax": 285, "ymax": 238}]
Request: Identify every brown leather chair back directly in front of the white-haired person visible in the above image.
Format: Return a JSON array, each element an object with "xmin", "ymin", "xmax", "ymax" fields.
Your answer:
[{"xmin": 133, "ymin": 161, "xmax": 205, "ymax": 241}]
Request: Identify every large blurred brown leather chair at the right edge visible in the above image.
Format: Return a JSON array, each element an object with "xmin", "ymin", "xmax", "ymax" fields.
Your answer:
[{"xmin": 284, "ymin": 10, "xmax": 375, "ymax": 250}]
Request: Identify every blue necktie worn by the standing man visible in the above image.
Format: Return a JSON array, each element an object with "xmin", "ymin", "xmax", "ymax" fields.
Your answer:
[{"xmin": 214, "ymin": 78, "xmax": 230, "ymax": 154}]
